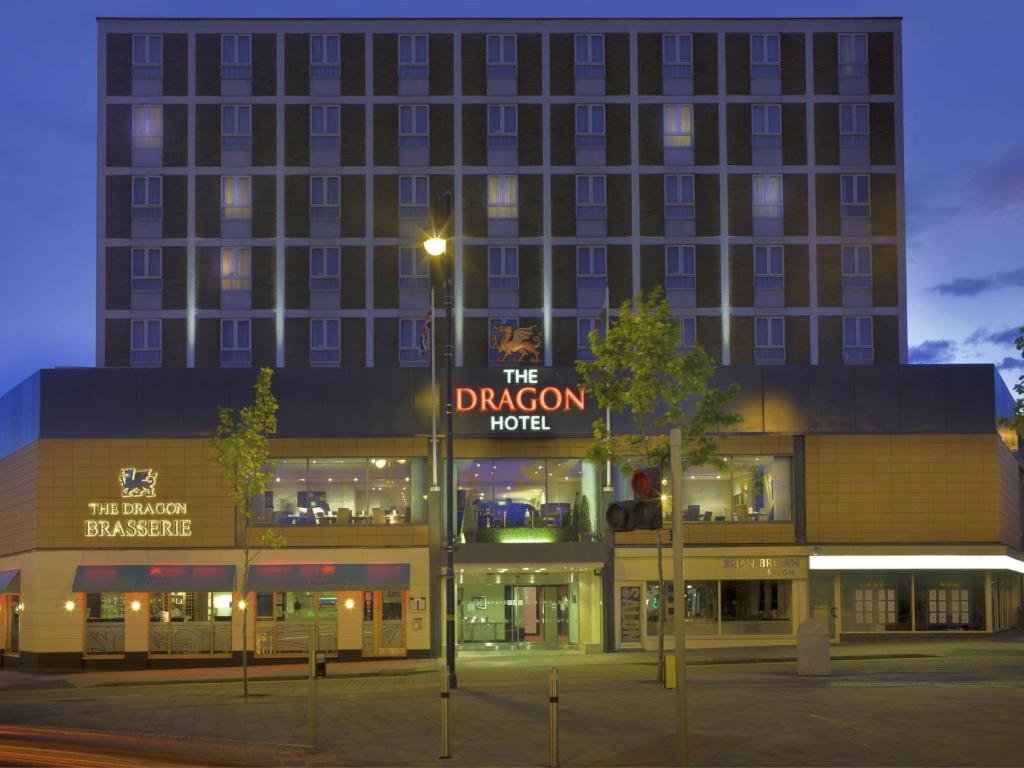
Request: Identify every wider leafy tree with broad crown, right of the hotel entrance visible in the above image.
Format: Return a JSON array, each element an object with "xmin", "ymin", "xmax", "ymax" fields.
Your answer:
[{"xmin": 577, "ymin": 289, "xmax": 740, "ymax": 680}]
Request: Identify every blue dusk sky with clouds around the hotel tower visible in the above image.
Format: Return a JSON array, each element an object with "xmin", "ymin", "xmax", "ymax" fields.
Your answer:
[{"xmin": 0, "ymin": 0, "xmax": 1024, "ymax": 393}]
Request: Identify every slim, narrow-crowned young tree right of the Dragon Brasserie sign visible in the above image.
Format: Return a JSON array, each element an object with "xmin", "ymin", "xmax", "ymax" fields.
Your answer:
[{"xmin": 210, "ymin": 368, "xmax": 284, "ymax": 696}]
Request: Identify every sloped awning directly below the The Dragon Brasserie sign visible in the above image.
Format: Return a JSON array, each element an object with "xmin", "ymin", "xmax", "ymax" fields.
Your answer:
[{"xmin": 73, "ymin": 565, "xmax": 234, "ymax": 592}]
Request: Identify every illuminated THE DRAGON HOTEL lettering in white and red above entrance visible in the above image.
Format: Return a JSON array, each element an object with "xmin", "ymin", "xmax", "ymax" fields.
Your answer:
[{"xmin": 455, "ymin": 368, "xmax": 586, "ymax": 432}]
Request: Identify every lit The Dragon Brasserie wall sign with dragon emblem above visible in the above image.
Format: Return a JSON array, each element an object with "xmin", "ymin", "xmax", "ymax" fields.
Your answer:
[{"xmin": 85, "ymin": 467, "xmax": 191, "ymax": 539}]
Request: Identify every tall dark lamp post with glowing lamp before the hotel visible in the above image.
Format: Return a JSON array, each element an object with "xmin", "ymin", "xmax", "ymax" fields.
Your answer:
[{"xmin": 423, "ymin": 191, "xmax": 459, "ymax": 688}]
